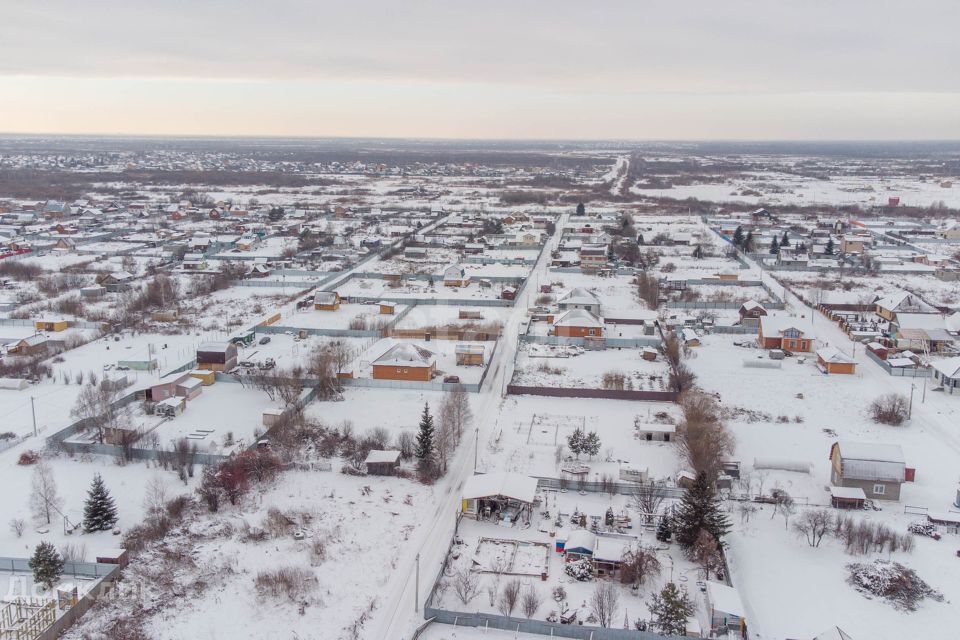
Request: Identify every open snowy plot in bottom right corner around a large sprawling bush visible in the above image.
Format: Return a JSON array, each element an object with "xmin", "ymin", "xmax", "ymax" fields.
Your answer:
[{"xmin": 726, "ymin": 505, "xmax": 960, "ymax": 639}]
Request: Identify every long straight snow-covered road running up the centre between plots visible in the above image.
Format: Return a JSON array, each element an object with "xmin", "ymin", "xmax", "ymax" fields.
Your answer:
[{"xmin": 367, "ymin": 215, "xmax": 567, "ymax": 639}]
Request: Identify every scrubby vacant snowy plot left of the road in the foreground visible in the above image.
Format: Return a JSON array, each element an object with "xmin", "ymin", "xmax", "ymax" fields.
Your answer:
[{"xmin": 66, "ymin": 464, "xmax": 436, "ymax": 640}]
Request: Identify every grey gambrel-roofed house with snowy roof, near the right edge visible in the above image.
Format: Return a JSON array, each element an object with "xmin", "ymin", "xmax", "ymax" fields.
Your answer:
[{"xmin": 830, "ymin": 440, "xmax": 912, "ymax": 500}]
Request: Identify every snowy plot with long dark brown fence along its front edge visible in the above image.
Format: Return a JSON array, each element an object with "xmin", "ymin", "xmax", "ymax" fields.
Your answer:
[{"xmin": 512, "ymin": 344, "xmax": 670, "ymax": 391}]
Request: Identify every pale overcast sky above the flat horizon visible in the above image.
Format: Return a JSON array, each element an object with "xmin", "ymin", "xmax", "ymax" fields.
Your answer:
[{"xmin": 0, "ymin": 0, "xmax": 960, "ymax": 139}]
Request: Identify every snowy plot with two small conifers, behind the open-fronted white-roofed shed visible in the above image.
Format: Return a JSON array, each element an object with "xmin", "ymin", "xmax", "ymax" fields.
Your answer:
[{"xmin": 488, "ymin": 396, "xmax": 684, "ymax": 482}]
